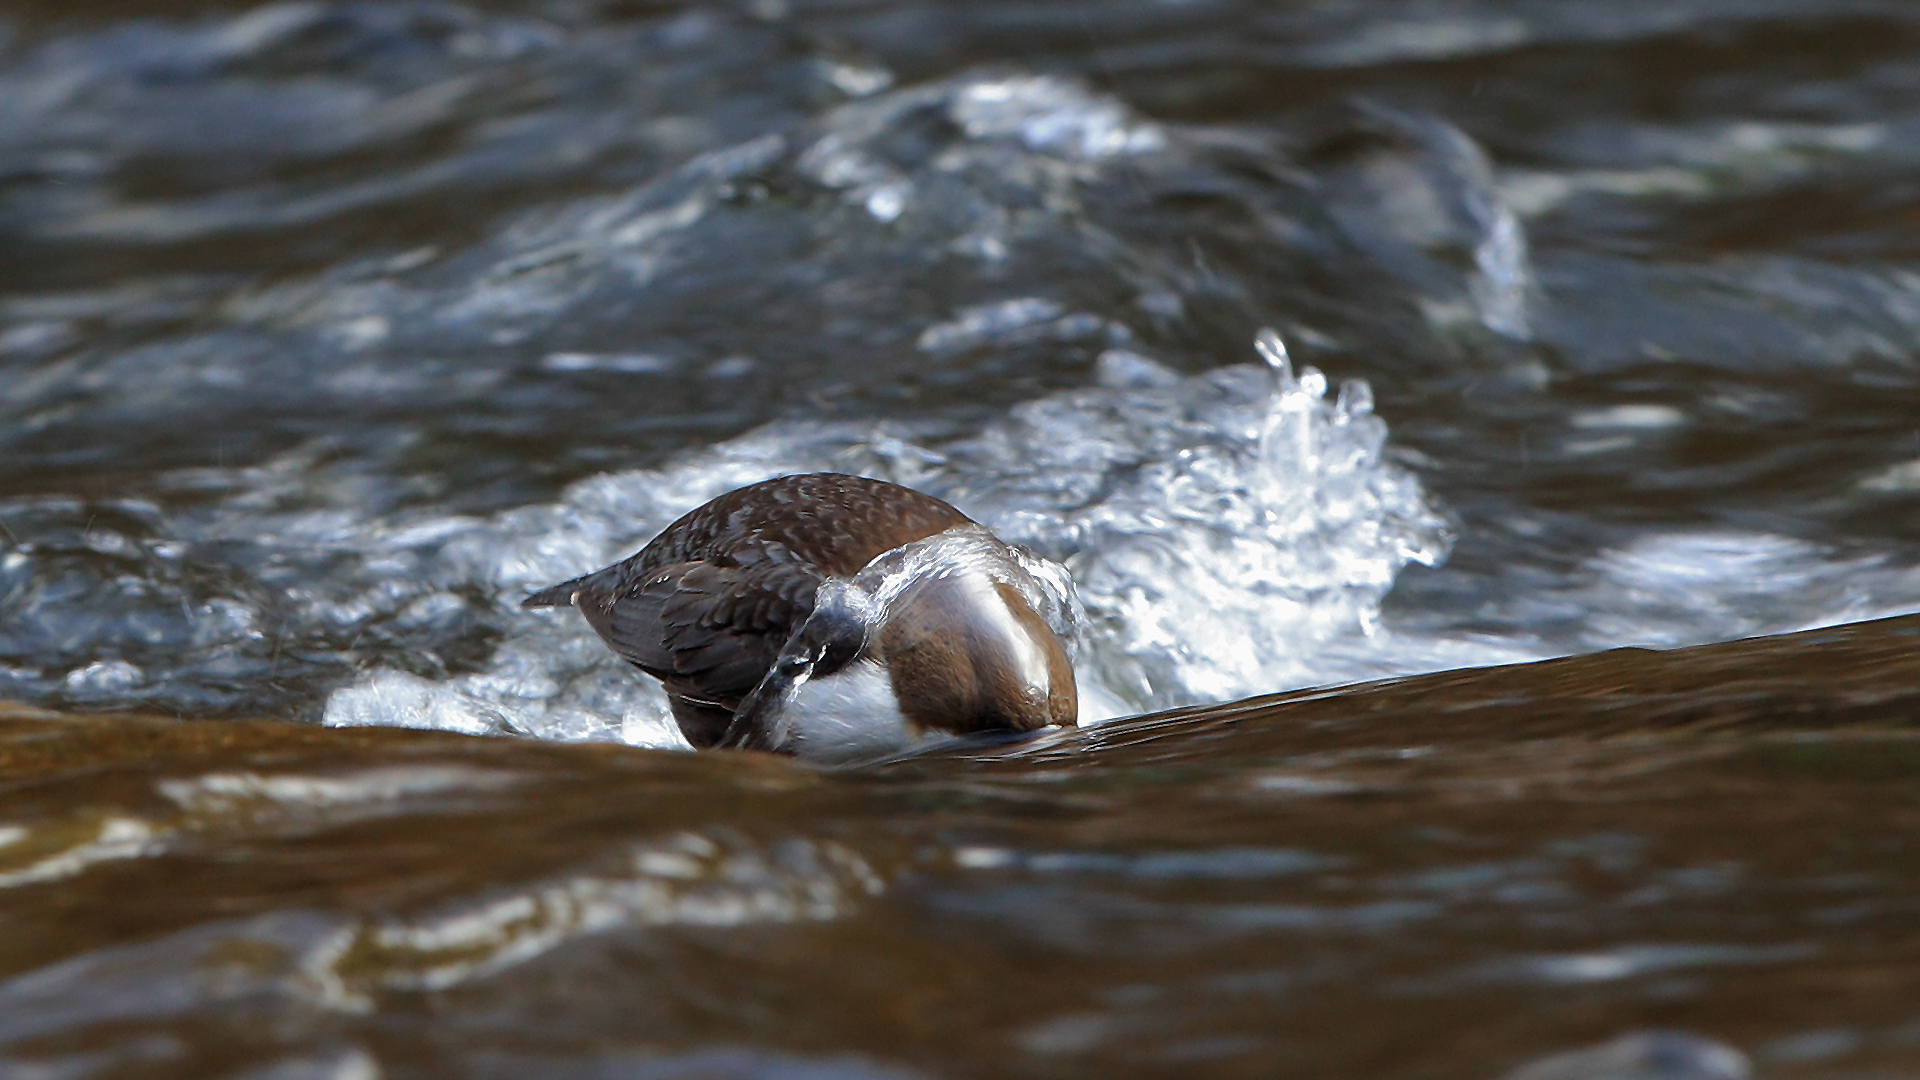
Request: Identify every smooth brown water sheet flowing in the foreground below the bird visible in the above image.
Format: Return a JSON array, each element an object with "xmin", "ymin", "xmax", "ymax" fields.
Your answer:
[{"xmin": 0, "ymin": 619, "xmax": 1920, "ymax": 1078}]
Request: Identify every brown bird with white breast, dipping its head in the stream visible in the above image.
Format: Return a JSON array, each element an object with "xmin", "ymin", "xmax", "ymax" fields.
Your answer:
[{"xmin": 522, "ymin": 473, "xmax": 1081, "ymax": 761}]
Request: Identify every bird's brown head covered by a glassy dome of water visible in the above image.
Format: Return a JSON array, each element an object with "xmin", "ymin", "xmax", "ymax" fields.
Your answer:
[{"xmin": 876, "ymin": 569, "xmax": 1079, "ymax": 734}]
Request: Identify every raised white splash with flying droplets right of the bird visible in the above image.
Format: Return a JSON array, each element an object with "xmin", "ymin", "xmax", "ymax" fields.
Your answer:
[{"xmin": 929, "ymin": 331, "xmax": 1450, "ymax": 709}]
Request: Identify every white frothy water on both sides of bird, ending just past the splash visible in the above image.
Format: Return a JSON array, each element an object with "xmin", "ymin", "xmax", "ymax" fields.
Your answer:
[{"xmin": 326, "ymin": 332, "xmax": 1482, "ymax": 746}]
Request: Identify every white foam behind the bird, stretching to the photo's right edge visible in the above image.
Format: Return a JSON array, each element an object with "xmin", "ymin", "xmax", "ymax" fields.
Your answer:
[{"xmin": 266, "ymin": 334, "xmax": 1920, "ymax": 748}]
